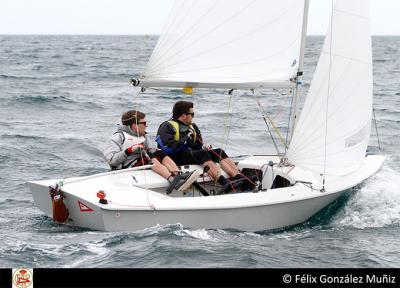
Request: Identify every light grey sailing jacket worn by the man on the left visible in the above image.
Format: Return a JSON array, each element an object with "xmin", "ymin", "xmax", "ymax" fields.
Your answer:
[{"xmin": 103, "ymin": 125, "xmax": 152, "ymax": 170}]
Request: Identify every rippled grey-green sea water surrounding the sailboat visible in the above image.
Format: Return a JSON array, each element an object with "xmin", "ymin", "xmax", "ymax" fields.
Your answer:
[{"xmin": 0, "ymin": 36, "xmax": 400, "ymax": 268}]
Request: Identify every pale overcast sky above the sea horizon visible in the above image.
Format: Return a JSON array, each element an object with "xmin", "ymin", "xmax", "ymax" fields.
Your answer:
[{"xmin": 0, "ymin": 0, "xmax": 400, "ymax": 35}]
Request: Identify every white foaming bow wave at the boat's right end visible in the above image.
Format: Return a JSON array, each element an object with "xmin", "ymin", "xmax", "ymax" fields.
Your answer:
[{"xmin": 332, "ymin": 165, "xmax": 400, "ymax": 229}]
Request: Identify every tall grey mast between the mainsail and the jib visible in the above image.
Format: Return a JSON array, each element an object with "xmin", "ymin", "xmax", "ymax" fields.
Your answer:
[{"xmin": 289, "ymin": 0, "xmax": 310, "ymax": 144}]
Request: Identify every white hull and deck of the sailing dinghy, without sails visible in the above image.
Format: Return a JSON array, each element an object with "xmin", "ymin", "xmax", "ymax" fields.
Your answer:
[{"xmin": 29, "ymin": 155, "xmax": 384, "ymax": 231}]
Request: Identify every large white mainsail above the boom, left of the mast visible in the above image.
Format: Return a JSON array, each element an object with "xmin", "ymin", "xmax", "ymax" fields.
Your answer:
[{"xmin": 143, "ymin": 0, "xmax": 304, "ymax": 88}]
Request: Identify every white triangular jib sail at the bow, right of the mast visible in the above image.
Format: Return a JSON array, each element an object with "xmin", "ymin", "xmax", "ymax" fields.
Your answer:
[{"xmin": 288, "ymin": 0, "xmax": 372, "ymax": 175}]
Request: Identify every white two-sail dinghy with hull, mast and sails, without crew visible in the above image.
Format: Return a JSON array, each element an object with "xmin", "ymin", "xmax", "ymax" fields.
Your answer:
[{"xmin": 29, "ymin": 0, "xmax": 384, "ymax": 231}]
